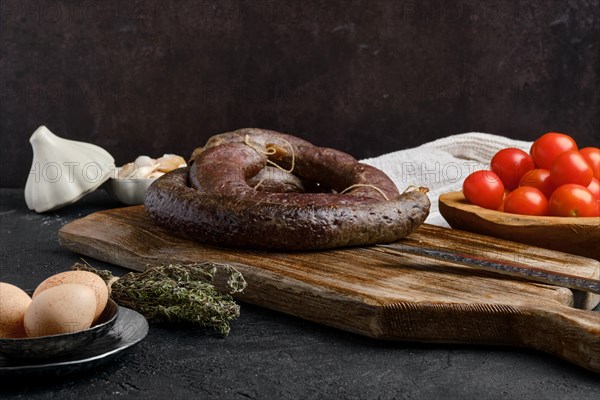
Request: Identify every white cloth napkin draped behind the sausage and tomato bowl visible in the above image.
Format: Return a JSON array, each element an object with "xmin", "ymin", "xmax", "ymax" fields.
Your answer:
[{"xmin": 361, "ymin": 132, "xmax": 532, "ymax": 227}]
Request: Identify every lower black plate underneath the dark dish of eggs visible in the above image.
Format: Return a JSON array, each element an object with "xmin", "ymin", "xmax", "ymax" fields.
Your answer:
[{"xmin": 0, "ymin": 307, "xmax": 148, "ymax": 378}]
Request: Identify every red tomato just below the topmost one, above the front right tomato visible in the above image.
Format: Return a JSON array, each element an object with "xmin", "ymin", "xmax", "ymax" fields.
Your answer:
[{"xmin": 550, "ymin": 150, "xmax": 594, "ymax": 187}]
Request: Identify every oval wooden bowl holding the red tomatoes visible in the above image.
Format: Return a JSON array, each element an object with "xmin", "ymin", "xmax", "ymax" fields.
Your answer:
[{"xmin": 439, "ymin": 192, "xmax": 600, "ymax": 260}]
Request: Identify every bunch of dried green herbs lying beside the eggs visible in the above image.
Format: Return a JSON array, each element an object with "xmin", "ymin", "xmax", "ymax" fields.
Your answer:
[{"xmin": 72, "ymin": 262, "xmax": 246, "ymax": 336}]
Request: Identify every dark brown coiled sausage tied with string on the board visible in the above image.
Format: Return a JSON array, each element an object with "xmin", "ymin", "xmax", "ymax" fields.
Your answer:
[{"xmin": 145, "ymin": 129, "xmax": 430, "ymax": 250}]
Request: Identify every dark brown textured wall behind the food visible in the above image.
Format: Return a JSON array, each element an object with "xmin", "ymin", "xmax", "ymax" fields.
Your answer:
[{"xmin": 0, "ymin": 0, "xmax": 600, "ymax": 186}]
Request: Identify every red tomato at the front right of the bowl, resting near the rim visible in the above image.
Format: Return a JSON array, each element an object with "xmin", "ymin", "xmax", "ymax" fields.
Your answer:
[{"xmin": 550, "ymin": 183, "xmax": 598, "ymax": 217}]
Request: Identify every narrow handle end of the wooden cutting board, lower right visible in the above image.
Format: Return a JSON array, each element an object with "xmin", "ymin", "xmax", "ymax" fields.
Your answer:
[{"xmin": 519, "ymin": 307, "xmax": 600, "ymax": 373}]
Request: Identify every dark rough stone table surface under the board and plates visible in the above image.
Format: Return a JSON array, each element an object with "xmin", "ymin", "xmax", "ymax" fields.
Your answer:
[{"xmin": 0, "ymin": 189, "xmax": 600, "ymax": 400}]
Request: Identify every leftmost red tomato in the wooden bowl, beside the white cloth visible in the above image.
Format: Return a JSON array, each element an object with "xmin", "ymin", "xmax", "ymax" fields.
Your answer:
[{"xmin": 463, "ymin": 170, "xmax": 504, "ymax": 210}]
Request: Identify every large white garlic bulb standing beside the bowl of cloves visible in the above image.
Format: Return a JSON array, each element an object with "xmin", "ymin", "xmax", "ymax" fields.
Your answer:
[{"xmin": 25, "ymin": 125, "xmax": 115, "ymax": 212}]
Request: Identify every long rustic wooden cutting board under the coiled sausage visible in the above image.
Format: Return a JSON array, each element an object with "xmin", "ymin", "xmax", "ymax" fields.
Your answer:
[{"xmin": 59, "ymin": 206, "xmax": 600, "ymax": 372}]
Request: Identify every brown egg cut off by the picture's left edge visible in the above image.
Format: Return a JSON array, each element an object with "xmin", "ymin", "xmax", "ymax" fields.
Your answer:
[{"xmin": 0, "ymin": 282, "xmax": 31, "ymax": 338}]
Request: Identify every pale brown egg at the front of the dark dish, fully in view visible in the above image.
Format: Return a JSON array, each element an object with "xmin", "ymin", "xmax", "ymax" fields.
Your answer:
[{"xmin": 23, "ymin": 283, "xmax": 96, "ymax": 337}]
